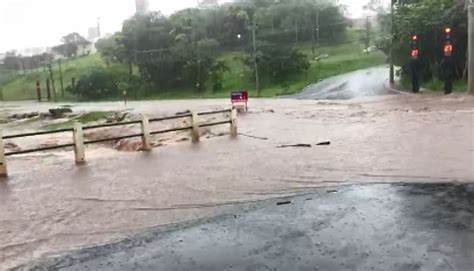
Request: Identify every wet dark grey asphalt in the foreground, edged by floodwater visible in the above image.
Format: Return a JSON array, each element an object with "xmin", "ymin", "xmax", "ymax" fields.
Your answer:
[{"xmin": 22, "ymin": 183, "xmax": 474, "ymax": 271}]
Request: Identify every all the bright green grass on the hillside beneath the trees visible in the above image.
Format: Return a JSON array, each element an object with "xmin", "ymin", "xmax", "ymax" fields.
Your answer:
[{"xmin": 0, "ymin": 38, "xmax": 385, "ymax": 100}]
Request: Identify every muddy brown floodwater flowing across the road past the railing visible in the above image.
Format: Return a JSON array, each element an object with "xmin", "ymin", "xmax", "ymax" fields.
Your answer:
[{"xmin": 0, "ymin": 94, "xmax": 474, "ymax": 269}]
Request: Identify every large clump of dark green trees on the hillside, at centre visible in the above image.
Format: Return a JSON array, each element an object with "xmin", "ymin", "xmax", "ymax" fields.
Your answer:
[{"xmin": 88, "ymin": 0, "xmax": 348, "ymax": 100}]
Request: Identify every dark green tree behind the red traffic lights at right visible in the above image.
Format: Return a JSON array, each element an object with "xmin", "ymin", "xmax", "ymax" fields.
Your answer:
[{"xmin": 378, "ymin": 0, "xmax": 467, "ymax": 80}]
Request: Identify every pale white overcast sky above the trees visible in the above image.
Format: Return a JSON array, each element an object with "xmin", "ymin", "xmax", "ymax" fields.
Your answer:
[{"xmin": 0, "ymin": 0, "xmax": 367, "ymax": 52}]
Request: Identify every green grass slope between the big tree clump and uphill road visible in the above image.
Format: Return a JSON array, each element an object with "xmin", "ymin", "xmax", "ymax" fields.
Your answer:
[{"xmin": 141, "ymin": 43, "xmax": 386, "ymax": 99}]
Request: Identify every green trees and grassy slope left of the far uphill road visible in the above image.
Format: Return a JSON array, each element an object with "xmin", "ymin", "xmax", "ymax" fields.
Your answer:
[{"xmin": 0, "ymin": 0, "xmax": 386, "ymax": 101}]
